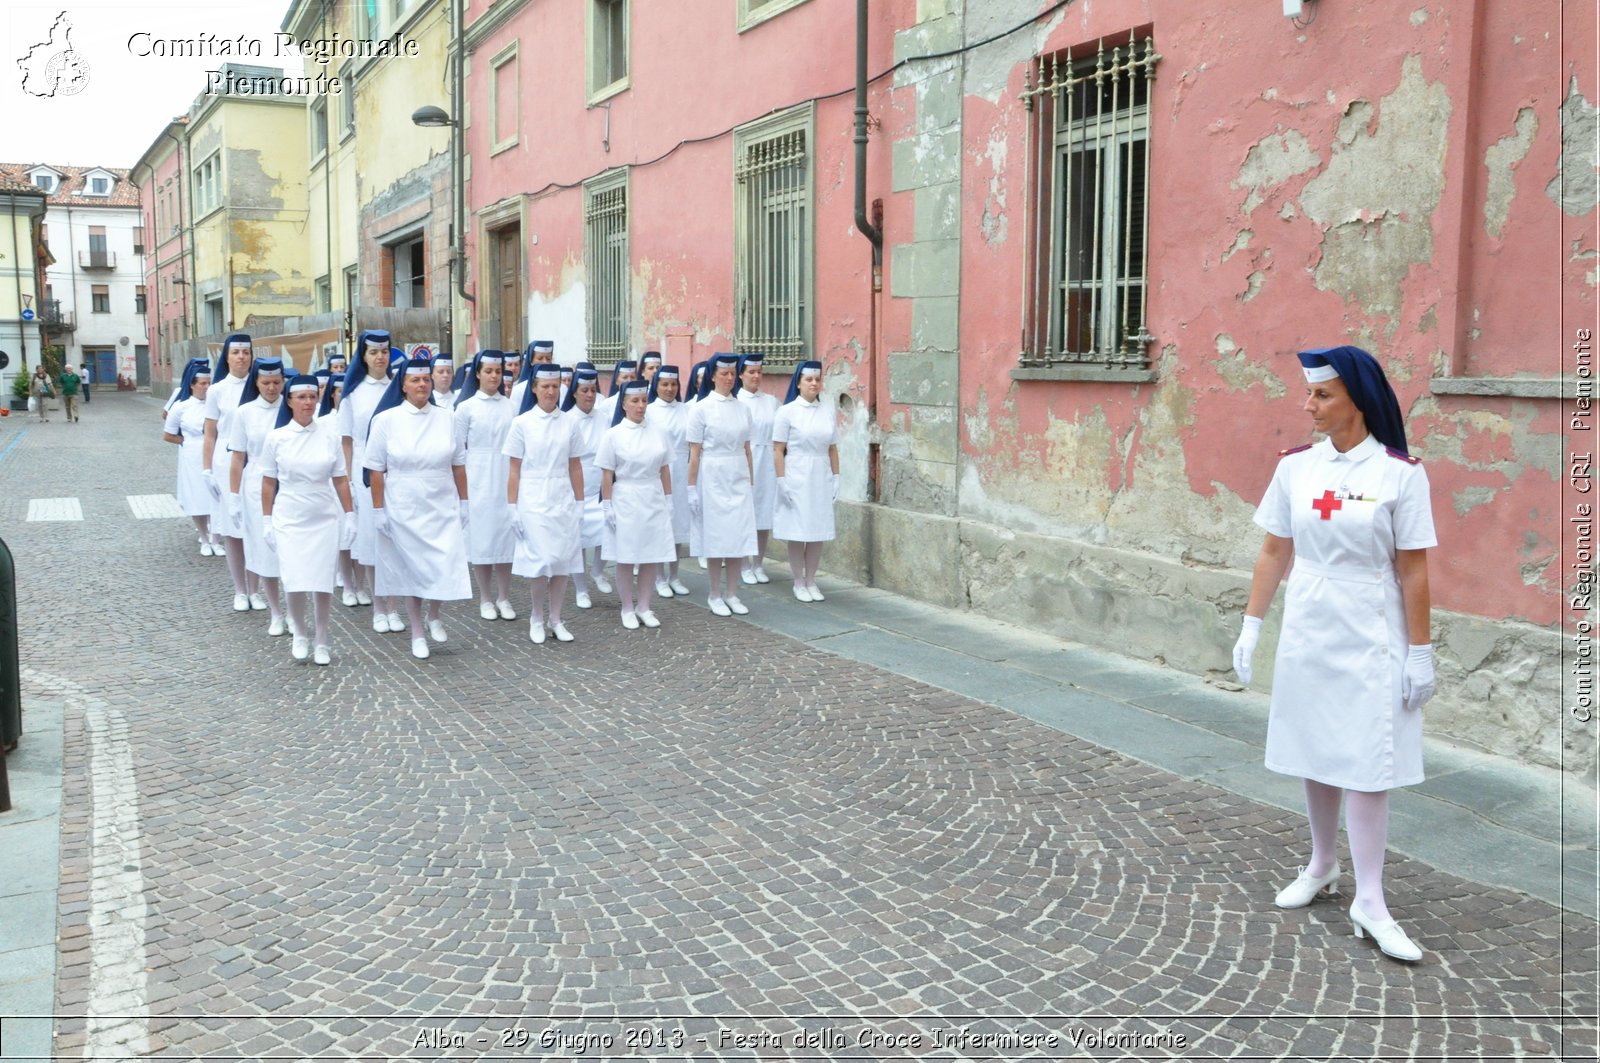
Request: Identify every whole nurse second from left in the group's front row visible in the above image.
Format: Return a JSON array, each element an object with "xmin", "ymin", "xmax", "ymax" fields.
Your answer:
[{"xmin": 363, "ymin": 359, "xmax": 472, "ymax": 660}]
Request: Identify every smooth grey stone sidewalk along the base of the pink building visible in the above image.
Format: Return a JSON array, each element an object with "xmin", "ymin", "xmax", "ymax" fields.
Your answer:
[{"xmin": 729, "ymin": 562, "xmax": 1600, "ymax": 919}]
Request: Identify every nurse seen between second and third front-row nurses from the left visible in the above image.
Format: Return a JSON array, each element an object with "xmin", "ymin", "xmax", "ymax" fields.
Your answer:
[{"xmin": 454, "ymin": 349, "xmax": 517, "ymax": 620}]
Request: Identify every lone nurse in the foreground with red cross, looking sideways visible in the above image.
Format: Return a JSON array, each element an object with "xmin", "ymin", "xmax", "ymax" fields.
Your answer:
[{"xmin": 1234, "ymin": 347, "xmax": 1438, "ymax": 962}]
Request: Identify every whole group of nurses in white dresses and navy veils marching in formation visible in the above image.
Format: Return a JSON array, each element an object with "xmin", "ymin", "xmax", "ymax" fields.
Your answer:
[{"xmin": 172, "ymin": 330, "xmax": 838, "ymax": 664}]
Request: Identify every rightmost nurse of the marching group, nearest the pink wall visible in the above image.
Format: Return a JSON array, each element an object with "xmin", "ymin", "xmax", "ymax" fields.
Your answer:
[{"xmin": 773, "ymin": 362, "xmax": 838, "ymax": 602}]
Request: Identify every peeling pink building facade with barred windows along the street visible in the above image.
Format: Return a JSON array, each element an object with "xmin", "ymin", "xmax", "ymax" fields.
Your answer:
[{"xmin": 466, "ymin": 0, "xmax": 1597, "ymax": 770}]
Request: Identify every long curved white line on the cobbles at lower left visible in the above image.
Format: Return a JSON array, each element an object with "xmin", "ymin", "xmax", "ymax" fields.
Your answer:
[{"xmin": 22, "ymin": 668, "xmax": 150, "ymax": 1060}]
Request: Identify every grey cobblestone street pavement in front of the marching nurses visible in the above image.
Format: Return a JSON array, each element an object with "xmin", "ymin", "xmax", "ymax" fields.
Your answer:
[{"xmin": 0, "ymin": 395, "xmax": 1597, "ymax": 1060}]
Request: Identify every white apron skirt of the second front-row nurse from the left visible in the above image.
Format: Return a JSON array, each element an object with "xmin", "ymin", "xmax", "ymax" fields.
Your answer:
[{"xmin": 373, "ymin": 471, "xmax": 472, "ymax": 602}]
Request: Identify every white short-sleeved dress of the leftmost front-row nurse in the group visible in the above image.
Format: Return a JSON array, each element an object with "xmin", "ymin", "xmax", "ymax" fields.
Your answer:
[{"xmin": 251, "ymin": 418, "xmax": 346, "ymax": 594}]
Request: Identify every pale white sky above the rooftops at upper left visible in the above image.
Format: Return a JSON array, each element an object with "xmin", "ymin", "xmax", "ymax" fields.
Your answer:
[{"xmin": 0, "ymin": 0, "xmax": 302, "ymax": 166}]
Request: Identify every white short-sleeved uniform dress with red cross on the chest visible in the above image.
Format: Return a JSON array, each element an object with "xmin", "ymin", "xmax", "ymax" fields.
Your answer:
[{"xmin": 1256, "ymin": 435, "xmax": 1438, "ymax": 791}]
